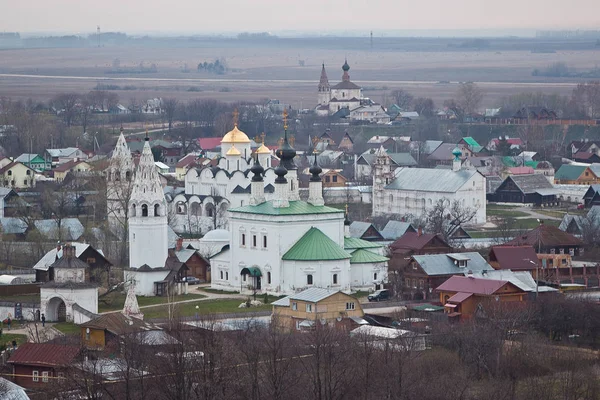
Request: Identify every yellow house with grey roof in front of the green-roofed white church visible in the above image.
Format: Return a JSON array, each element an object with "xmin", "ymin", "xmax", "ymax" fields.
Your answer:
[{"xmin": 271, "ymin": 288, "xmax": 366, "ymax": 331}]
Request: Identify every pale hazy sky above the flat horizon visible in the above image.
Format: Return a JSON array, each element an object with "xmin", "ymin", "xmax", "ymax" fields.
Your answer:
[{"xmin": 0, "ymin": 0, "xmax": 600, "ymax": 33}]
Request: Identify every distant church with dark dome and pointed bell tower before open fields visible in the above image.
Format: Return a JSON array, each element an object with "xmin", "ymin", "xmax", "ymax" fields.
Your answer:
[{"xmin": 316, "ymin": 60, "xmax": 368, "ymax": 116}]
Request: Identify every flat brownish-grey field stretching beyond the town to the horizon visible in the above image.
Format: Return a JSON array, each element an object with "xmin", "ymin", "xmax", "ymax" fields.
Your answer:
[{"xmin": 0, "ymin": 42, "xmax": 600, "ymax": 108}]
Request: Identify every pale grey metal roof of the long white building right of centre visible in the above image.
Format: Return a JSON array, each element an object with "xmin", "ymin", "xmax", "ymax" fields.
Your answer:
[{"xmin": 385, "ymin": 168, "xmax": 479, "ymax": 193}]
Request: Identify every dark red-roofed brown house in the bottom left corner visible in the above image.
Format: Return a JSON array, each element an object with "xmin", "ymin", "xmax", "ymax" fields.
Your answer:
[{"xmin": 8, "ymin": 343, "xmax": 80, "ymax": 389}]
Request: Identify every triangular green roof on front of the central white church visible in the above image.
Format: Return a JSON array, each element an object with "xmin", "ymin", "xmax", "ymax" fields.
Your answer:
[{"xmin": 281, "ymin": 227, "xmax": 352, "ymax": 261}]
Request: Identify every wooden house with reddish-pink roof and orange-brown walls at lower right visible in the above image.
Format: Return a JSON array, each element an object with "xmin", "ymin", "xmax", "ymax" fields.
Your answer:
[{"xmin": 436, "ymin": 276, "xmax": 527, "ymax": 321}]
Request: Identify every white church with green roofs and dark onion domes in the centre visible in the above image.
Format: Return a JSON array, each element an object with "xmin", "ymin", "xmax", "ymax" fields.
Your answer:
[{"xmin": 211, "ymin": 133, "xmax": 387, "ymax": 294}]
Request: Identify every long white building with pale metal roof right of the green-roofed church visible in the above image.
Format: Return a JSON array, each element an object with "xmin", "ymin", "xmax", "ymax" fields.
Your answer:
[{"xmin": 373, "ymin": 147, "xmax": 486, "ymax": 224}]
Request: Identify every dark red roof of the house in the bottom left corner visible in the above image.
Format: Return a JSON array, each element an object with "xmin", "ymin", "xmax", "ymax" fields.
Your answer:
[{"xmin": 8, "ymin": 343, "xmax": 79, "ymax": 366}]
